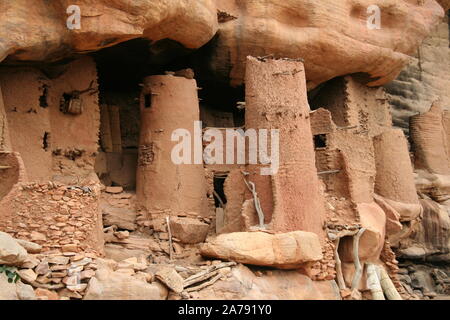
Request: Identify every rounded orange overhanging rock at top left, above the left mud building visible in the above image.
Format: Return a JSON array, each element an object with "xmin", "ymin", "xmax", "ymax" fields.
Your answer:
[{"xmin": 0, "ymin": 0, "xmax": 217, "ymax": 61}]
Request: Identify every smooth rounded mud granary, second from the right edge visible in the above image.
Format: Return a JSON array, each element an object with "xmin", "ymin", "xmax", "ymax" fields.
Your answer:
[{"xmin": 373, "ymin": 129, "xmax": 419, "ymax": 204}]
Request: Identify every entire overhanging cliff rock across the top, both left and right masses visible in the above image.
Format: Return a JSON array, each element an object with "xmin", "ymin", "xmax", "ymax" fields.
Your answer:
[{"xmin": 0, "ymin": 0, "xmax": 448, "ymax": 88}]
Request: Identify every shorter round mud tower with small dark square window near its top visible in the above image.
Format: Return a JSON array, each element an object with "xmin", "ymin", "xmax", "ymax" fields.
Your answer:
[{"xmin": 136, "ymin": 75, "xmax": 207, "ymax": 218}]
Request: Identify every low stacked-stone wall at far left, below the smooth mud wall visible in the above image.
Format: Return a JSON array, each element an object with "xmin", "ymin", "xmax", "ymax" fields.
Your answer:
[{"xmin": 0, "ymin": 182, "xmax": 103, "ymax": 254}]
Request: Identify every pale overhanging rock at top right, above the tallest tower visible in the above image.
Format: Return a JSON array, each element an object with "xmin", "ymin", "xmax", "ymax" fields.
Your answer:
[{"xmin": 209, "ymin": 0, "xmax": 444, "ymax": 88}]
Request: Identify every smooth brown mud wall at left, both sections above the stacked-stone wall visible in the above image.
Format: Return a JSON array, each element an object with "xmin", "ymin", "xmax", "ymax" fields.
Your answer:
[{"xmin": 0, "ymin": 57, "xmax": 99, "ymax": 184}]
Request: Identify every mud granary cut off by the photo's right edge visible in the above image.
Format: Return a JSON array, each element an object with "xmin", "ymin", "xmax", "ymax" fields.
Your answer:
[{"xmin": 409, "ymin": 102, "xmax": 450, "ymax": 175}]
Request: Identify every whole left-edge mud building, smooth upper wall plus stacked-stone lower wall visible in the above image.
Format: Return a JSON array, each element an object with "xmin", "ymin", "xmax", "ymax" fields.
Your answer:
[{"xmin": 0, "ymin": 57, "xmax": 103, "ymax": 253}]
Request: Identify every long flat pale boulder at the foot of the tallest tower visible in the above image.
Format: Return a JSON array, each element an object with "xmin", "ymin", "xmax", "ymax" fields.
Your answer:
[{"xmin": 201, "ymin": 231, "xmax": 322, "ymax": 269}]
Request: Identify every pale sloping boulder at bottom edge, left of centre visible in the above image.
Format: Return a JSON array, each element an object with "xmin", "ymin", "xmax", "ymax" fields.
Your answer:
[{"xmin": 84, "ymin": 264, "xmax": 168, "ymax": 300}]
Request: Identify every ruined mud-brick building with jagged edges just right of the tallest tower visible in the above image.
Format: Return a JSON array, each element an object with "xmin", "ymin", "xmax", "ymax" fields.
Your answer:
[{"xmin": 311, "ymin": 75, "xmax": 392, "ymax": 203}]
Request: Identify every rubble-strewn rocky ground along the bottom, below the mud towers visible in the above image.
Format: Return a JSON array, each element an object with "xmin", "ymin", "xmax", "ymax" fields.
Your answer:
[{"xmin": 0, "ymin": 187, "xmax": 450, "ymax": 300}]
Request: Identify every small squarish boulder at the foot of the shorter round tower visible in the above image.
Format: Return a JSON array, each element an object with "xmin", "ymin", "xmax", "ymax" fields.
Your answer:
[{"xmin": 170, "ymin": 217, "xmax": 209, "ymax": 244}]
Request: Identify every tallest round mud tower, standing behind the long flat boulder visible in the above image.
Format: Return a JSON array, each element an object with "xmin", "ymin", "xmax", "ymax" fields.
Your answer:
[{"xmin": 245, "ymin": 57, "xmax": 325, "ymax": 239}]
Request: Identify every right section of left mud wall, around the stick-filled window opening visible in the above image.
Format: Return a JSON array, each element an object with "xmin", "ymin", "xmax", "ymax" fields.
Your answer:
[{"xmin": 48, "ymin": 57, "xmax": 100, "ymax": 184}]
